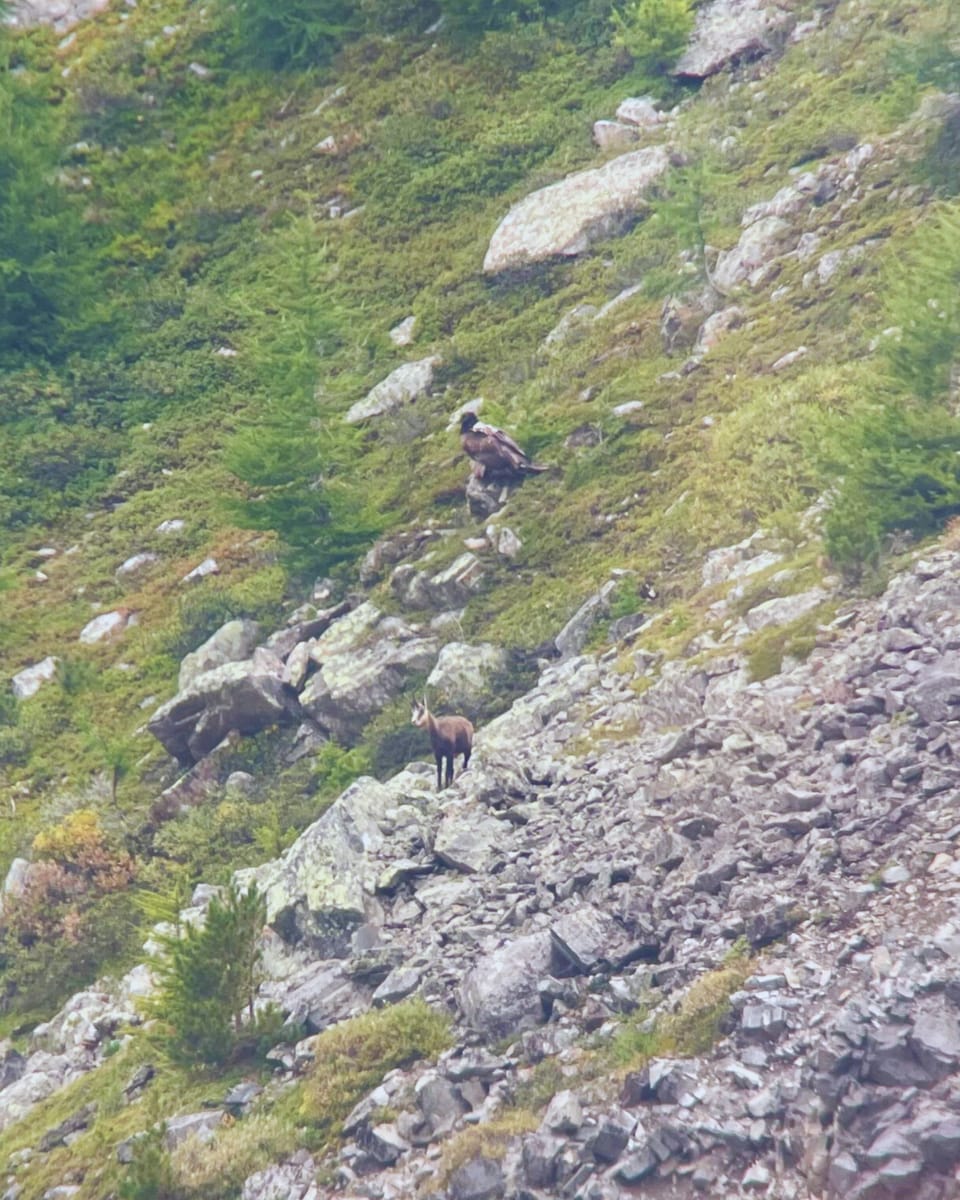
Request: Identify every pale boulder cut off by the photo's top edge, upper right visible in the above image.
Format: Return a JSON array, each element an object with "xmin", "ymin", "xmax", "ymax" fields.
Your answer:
[{"xmin": 673, "ymin": 0, "xmax": 790, "ymax": 79}]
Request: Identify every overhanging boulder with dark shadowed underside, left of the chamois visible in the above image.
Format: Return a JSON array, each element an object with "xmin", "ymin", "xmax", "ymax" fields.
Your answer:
[{"xmin": 146, "ymin": 648, "xmax": 299, "ymax": 766}]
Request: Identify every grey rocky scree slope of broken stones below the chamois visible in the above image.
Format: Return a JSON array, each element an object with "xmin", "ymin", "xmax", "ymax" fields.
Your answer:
[{"xmin": 0, "ymin": 550, "xmax": 960, "ymax": 1200}]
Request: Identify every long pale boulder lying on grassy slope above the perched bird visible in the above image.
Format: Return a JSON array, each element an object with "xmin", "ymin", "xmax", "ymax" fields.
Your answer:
[{"xmin": 484, "ymin": 146, "xmax": 670, "ymax": 275}]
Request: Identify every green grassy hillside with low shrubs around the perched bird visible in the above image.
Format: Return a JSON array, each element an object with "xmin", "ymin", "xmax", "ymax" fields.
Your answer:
[{"xmin": 0, "ymin": 0, "xmax": 960, "ymax": 1027}]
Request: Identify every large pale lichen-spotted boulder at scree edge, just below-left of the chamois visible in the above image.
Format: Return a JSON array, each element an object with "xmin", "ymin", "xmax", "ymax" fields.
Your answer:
[{"xmin": 235, "ymin": 776, "xmax": 397, "ymax": 958}]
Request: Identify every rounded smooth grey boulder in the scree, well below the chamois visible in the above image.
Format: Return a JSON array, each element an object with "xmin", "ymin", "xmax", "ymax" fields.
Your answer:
[{"xmin": 460, "ymin": 932, "xmax": 551, "ymax": 1038}]
